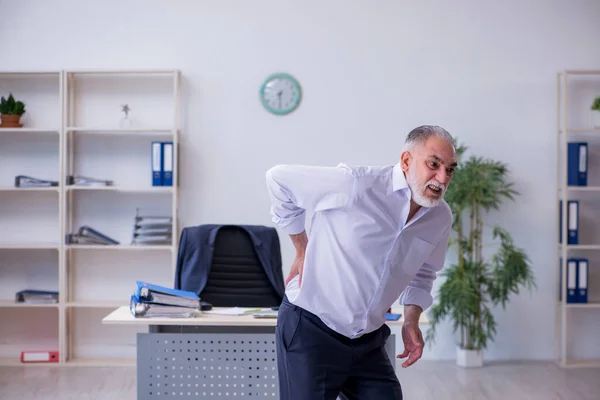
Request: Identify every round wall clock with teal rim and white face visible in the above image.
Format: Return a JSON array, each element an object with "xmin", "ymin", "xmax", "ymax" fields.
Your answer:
[{"xmin": 260, "ymin": 73, "xmax": 302, "ymax": 115}]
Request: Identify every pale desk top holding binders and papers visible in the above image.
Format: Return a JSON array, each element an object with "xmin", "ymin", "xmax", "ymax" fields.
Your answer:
[{"xmin": 102, "ymin": 306, "xmax": 428, "ymax": 326}]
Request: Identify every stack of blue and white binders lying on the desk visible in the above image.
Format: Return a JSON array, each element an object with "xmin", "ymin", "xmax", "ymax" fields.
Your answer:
[{"xmin": 129, "ymin": 281, "xmax": 201, "ymax": 318}]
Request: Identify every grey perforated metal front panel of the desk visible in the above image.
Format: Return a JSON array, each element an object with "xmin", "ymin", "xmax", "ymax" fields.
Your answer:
[{"xmin": 137, "ymin": 333, "xmax": 279, "ymax": 400}]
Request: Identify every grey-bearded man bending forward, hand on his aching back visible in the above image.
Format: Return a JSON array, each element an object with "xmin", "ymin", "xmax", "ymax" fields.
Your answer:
[{"xmin": 266, "ymin": 126, "xmax": 456, "ymax": 400}]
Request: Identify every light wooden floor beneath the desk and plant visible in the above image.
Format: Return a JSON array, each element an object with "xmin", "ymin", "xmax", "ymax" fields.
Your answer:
[{"xmin": 0, "ymin": 360, "xmax": 600, "ymax": 400}]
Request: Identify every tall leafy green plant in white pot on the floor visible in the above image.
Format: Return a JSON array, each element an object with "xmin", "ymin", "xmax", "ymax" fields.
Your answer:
[{"xmin": 426, "ymin": 142, "xmax": 535, "ymax": 367}]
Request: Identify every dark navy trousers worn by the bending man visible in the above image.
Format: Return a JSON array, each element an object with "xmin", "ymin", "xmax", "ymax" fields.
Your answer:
[{"xmin": 275, "ymin": 298, "xmax": 402, "ymax": 400}]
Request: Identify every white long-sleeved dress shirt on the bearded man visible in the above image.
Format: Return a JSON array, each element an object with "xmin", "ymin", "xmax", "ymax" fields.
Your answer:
[{"xmin": 266, "ymin": 164, "xmax": 452, "ymax": 338}]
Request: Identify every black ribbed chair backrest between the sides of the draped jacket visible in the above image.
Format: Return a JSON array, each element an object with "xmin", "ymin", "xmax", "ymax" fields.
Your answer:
[{"xmin": 200, "ymin": 226, "xmax": 281, "ymax": 307}]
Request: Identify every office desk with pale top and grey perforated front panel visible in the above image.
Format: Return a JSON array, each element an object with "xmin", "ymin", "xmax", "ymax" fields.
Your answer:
[{"xmin": 102, "ymin": 306, "xmax": 426, "ymax": 400}]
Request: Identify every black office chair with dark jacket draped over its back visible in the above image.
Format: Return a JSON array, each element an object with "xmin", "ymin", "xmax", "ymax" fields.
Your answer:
[{"xmin": 174, "ymin": 224, "xmax": 285, "ymax": 308}]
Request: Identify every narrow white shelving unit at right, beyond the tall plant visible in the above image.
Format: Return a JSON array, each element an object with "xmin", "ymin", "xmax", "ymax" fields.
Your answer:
[{"xmin": 555, "ymin": 70, "xmax": 600, "ymax": 367}]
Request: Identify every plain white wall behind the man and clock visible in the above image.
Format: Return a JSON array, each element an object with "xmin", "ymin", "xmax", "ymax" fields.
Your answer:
[{"xmin": 0, "ymin": 0, "xmax": 600, "ymax": 359}]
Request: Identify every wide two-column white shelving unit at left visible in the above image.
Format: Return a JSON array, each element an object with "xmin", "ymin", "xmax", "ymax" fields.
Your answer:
[{"xmin": 0, "ymin": 70, "xmax": 181, "ymax": 366}]
